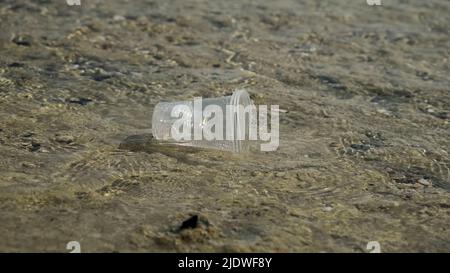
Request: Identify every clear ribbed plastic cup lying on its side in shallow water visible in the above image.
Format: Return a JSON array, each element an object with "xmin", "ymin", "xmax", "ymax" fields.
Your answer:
[{"xmin": 152, "ymin": 90, "xmax": 253, "ymax": 152}]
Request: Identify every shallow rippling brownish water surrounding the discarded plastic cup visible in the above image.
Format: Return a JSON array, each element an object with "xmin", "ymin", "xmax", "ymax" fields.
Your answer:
[{"xmin": 0, "ymin": 0, "xmax": 450, "ymax": 252}]
